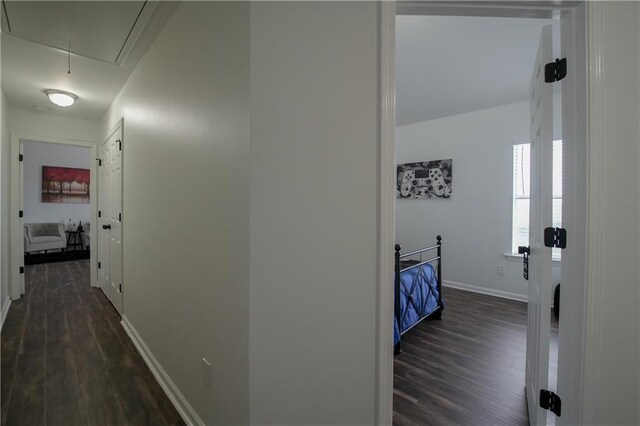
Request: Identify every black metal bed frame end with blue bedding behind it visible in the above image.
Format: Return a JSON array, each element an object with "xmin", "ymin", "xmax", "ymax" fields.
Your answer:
[{"xmin": 394, "ymin": 235, "xmax": 444, "ymax": 354}]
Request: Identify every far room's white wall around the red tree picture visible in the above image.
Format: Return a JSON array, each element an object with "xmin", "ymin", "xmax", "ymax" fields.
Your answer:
[{"xmin": 23, "ymin": 141, "xmax": 90, "ymax": 224}]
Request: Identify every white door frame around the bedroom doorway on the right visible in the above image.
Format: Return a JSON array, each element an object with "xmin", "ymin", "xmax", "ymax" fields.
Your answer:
[{"xmin": 375, "ymin": 1, "xmax": 604, "ymax": 425}]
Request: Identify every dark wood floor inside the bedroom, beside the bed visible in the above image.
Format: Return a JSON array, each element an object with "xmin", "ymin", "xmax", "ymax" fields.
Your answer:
[{"xmin": 393, "ymin": 288, "xmax": 557, "ymax": 426}]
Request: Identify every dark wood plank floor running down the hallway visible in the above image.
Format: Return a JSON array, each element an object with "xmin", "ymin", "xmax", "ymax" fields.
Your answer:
[{"xmin": 1, "ymin": 260, "xmax": 183, "ymax": 425}]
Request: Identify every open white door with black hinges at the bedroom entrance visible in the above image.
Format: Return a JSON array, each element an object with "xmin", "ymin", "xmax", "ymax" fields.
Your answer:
[{"xmin": 525, "ymin": 25, "xmax": 553, "ymax": 425}]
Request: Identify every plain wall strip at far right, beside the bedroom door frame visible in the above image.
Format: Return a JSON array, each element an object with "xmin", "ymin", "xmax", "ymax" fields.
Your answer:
[{"xmin": 581, "ymin": 2, "xmax": 640, "ymax": 425}]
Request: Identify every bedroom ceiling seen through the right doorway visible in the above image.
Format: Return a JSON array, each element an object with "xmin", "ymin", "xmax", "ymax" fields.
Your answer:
[{"xmin": 396, "ymin": 16, "xmax": 552, "ymax": 126}]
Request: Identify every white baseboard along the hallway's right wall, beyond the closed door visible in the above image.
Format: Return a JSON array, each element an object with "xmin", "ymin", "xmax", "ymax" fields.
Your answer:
[{"xmin": 121, "ymin": 315, "xmax": 204, "ymax": 426}]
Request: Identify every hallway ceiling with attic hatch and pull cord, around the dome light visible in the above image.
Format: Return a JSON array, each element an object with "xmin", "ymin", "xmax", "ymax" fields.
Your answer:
[{"xmin": 2, "ymin": 1, "xmax": 175, "ymax": 120}]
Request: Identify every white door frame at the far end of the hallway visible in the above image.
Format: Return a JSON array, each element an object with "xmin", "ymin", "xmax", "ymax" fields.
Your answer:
[{"xmin": 9, "ymin": 133, "xmax": 98, "ymax": 300}]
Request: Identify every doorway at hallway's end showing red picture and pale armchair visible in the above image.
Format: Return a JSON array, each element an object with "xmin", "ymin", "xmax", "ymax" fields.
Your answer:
[{"xmin": 10, "ymin": 134, "xmax": 97, "ymax": 300}]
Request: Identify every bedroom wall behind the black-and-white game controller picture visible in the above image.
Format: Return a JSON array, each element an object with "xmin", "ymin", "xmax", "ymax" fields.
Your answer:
[{"xmin": 396, "ymin": 101, "xmax": 560, "ymax": 300}]
